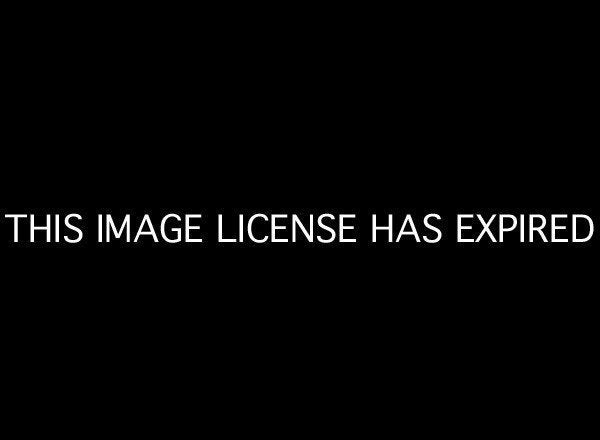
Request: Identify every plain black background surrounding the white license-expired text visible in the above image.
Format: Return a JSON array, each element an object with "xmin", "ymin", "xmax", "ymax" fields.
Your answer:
[{"xmin": 1, "ymin": 5, "xmax": 598, "ymax": 433}]
